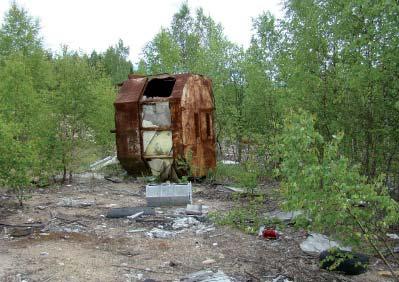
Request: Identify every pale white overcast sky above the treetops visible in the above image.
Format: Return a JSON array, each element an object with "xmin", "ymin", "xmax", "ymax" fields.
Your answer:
[{"xmin": 0, "ymin": 0, "xmax": 282, "ymax": 63}]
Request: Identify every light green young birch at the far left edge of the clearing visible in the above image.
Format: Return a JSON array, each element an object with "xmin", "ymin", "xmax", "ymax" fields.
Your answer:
[{"xmin": 0, "ymin": 40, "xmax": 45, "ymax": 205}]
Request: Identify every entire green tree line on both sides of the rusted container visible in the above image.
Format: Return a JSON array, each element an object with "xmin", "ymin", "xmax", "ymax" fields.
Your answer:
[{"xmin": 0, "ymin": 0, "xmax": 399, "ymax": 198}]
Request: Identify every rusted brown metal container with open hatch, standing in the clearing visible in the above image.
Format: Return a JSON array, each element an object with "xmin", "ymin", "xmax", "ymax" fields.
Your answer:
[{"xmin": 114, "ymin": 73, "xmax": 216, "ymax": 178}]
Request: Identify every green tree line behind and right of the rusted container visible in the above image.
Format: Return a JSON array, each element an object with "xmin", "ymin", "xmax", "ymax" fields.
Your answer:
[{"xmin": 138, "ymin": 0, "xmax": 399, "ymax": 196}]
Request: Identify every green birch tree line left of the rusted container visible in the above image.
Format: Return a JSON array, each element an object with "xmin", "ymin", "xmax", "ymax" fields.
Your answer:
[{"xmin": 0, "ymin": 3, "xmax": 132, "ymax": 199}]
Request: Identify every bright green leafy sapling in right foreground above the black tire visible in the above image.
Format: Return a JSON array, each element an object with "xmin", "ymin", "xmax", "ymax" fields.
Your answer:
[{"xmin": 278, "ymin": 111, "xmax": 399, "ymax": 249}]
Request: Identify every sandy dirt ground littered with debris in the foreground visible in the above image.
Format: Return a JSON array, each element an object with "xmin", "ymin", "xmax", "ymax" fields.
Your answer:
[{"xmin": 0, "ymin": 177, "xmax": 396, "ymax": 282}]
